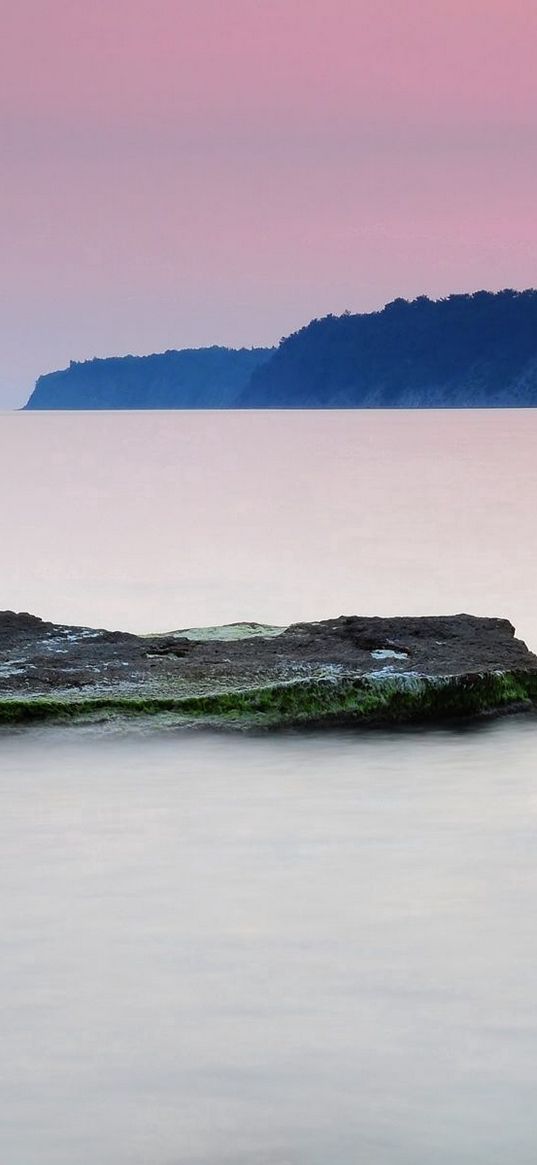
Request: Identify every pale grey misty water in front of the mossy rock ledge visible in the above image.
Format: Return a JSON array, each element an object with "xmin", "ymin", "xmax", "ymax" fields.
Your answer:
[{"xmin": 0, "ymin": 719, "xmax": 537, "ymax": 1165}]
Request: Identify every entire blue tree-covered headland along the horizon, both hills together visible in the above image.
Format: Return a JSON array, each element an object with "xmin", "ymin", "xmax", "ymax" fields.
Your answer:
[{"xmin": 27, "ymin": 291, "xmax": 537, "ymax": 409}]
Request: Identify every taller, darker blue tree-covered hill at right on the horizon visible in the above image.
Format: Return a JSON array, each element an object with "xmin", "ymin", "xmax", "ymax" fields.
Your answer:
[{"xmin": 240, "ymin": 290, "xmax": 537, "ymax": 408}]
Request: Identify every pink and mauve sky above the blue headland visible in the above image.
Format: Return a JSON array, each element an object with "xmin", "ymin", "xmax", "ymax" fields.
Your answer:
[{"xmin": 0, "ymin": 0, "xmax": 537, "ymax": 408}]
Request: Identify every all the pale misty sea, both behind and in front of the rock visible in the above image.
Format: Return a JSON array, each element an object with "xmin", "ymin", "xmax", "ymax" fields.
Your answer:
[{"xmin": 0, "ymin": 412, "xmax": 537, "ymax": 1165}]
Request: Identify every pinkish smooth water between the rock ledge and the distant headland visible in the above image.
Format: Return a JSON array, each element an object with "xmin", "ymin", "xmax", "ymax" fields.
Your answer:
[{"xmin": 0, "ymin": 409, "xmax": 537, "ymax": 648}]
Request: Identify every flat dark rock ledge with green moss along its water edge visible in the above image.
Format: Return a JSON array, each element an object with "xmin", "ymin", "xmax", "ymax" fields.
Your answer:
[{"xmin": 0, "ymin": 610, "xmax": 537, "ymax": 728}]
